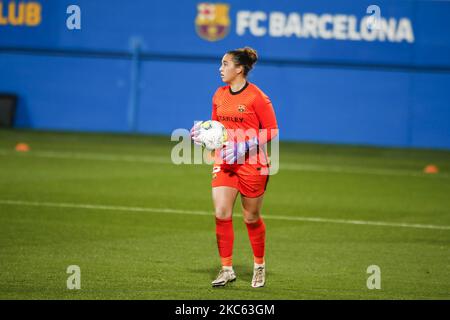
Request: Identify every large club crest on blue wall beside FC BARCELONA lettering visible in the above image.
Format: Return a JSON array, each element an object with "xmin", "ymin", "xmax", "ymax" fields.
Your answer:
[{"xmin": 195, "ymin": 2, "xmax": 230, "ymax": 41}]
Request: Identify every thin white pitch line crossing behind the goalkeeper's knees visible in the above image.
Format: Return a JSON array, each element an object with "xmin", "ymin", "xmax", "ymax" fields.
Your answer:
[{"xmin": 0, "ymin": 199, "xmax": 450, "ymax": 230}]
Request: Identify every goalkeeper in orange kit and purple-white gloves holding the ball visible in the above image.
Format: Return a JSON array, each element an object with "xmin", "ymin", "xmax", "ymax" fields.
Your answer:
[{"xmin": 191, "ymin": 47, "xmax": 278, "ymax": 288}]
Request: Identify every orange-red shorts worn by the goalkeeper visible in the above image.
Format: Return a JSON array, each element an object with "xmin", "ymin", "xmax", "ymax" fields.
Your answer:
[{"xmin": 211, "ymin": 164, "xmax": 269, "ymax": 198}]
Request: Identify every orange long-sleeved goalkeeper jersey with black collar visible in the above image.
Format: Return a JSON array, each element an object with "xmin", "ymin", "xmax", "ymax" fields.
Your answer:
[{"xmin": 211, "ymin": 82, "xmax": 278, "ymax": 166}]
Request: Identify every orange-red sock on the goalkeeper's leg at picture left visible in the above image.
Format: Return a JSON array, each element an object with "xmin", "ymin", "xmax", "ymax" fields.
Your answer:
[{"xmin": 216, "ymin": 218, "xmax": 234, "ymax": 267}]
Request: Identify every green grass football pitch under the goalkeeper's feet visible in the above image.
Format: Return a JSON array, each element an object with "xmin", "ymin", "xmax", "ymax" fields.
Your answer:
[{"xmin": 0, "ymin": 130, "xmax": 450, "ymax": 299}]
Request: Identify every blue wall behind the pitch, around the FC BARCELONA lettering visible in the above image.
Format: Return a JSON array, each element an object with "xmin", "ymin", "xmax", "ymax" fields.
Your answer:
[{"xmin": 0, "ymin": 0, "xmax": 450, "ymax": 149}]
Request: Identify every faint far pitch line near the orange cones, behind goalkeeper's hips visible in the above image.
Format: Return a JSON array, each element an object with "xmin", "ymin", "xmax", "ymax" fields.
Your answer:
[{"xmin": 0, "ymin": 149, "xmax": 450, "ymax": 178}]
